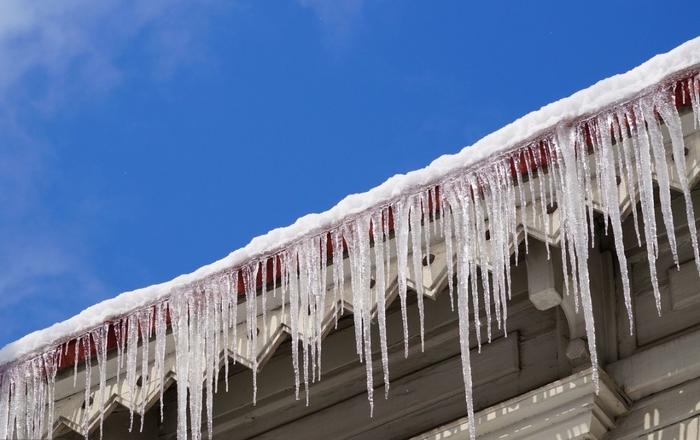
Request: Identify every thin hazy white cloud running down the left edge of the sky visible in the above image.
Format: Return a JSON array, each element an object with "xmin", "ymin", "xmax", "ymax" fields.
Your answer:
[{"xmin": 0, "ymin": 0, "xmax": 224, "ymax": 345}]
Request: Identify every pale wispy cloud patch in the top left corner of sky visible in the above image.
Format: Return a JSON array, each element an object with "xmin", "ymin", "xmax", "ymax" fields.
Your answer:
[{"xmin": 0, "ymin": 0, "xmax": 221, "ymax": 108}]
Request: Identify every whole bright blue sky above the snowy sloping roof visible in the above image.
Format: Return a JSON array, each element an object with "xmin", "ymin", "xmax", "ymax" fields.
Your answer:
[{"xmin": 0, "ymin": 0, "xmax": 700, "ymax": 345}]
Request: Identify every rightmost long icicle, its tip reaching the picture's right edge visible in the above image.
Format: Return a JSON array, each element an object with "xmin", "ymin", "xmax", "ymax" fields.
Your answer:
[{"xmin": 657, "ymin": 93, "xmax": 700, "ymax": 273}]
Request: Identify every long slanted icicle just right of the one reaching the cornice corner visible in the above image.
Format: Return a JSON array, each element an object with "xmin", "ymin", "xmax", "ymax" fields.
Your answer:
[{"xmin": 598, "ymin": 115, "xmax": 634, "ymax": 334}]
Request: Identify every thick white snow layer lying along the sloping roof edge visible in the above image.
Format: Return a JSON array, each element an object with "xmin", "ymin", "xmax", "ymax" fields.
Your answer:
[{"xmin": 0, "ymin": 37, "xmax": 700, "ymax": 366}]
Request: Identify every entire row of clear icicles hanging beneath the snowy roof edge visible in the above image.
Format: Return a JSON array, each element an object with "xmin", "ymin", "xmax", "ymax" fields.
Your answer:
[{"xmin": 0, "ymin": 75, "xmax": 700, "ymax": 440}]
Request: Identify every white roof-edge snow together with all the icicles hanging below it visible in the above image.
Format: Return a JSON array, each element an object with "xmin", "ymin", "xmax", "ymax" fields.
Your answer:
[{"xmin": 0, "ymin": 39, "xmax": 700, "ymax": 439}]
